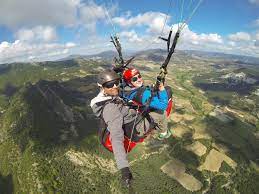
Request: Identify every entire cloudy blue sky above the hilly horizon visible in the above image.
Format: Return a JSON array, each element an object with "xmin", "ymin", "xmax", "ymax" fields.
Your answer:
[{"xmin": 0, "ymin": 0, "xmax": 259, "ymax": 64}]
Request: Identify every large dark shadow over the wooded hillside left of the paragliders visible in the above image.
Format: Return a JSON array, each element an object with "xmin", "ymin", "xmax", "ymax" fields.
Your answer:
[{"xmin": 6, "ymin": 76, "xmax": 98, "ymax": 151}]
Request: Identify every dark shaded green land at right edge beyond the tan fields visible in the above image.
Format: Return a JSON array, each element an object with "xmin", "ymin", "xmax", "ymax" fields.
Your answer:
[{"xmin": 204, "ymin": 116, "xmax": 259, "ymax": 163}]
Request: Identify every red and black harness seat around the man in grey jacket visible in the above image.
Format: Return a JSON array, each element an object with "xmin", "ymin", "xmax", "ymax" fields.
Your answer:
[{"xmin": 98, "ymin": 100, "xmax": 156, "ymax": 153}]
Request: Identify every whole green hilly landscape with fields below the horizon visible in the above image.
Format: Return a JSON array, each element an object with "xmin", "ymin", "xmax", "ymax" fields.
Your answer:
[{"xmin": 0, "ymin": 51, "xmax": 259, "ymax": 193}]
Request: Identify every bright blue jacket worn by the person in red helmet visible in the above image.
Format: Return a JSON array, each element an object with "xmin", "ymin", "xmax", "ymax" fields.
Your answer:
[{"xmin": 123, "ymin": 86, "xmax": 168, "ymax": 110}]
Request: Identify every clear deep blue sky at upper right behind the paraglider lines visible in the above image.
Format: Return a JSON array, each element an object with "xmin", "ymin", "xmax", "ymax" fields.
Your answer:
[{"xmin": 113, "ymin": 0, "xmax": 259, "ymax": 35}]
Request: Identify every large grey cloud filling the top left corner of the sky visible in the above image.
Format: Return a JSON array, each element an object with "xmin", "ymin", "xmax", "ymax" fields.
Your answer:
[{"xmin": 0, "ymin": 0, "xmax": 117, "ymax": 31}]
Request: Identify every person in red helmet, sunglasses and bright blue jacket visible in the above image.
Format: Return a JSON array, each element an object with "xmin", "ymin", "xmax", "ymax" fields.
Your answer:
[{"xmin": 121, "ymin": 68, "xmax": 172, "ymax": 139}]
